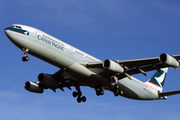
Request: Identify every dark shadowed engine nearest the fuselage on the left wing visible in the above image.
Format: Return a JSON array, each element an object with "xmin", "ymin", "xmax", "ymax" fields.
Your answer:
[{"xmin": 38, "ymin": 73, "xmax": 59, "ymax": 88}]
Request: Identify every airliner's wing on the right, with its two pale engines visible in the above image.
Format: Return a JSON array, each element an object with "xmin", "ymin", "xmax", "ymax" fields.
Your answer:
[{"xmin": 81, "ymin": 53, "xmax": 180, "ymax": 79}]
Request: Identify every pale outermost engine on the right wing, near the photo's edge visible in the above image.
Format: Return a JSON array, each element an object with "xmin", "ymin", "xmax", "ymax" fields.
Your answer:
[{"xmin": 159, "ymin": 53, "xmax": 179, "ymax": 68}]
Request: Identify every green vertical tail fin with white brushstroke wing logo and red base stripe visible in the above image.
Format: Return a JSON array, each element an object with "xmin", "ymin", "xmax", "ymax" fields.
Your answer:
[{"xmin": 146, "ymin": 68, "xmax": 168, "ymax": 92}]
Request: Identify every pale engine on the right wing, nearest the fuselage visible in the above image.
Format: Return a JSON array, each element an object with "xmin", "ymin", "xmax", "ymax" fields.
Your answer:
[{"xmin": 103, "ymin": 59, "xmax": 124, "ymax": 73}]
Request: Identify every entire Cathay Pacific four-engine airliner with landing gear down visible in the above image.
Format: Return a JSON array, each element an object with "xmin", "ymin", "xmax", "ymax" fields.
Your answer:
[{"xmin": 5, "ymin": 24, "xmax": 180, "ymax": 103}]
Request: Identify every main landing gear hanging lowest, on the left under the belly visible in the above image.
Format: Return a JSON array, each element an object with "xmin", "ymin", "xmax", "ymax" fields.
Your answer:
[{"xmin": 73, "ymin": 86, "xmax": 86, "ymax": 103}]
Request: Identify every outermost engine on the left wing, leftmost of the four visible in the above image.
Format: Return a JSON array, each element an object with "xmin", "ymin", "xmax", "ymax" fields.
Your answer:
[{"xmin": 24, "ymin": 81, "xmax": 44, "ymax": 93}]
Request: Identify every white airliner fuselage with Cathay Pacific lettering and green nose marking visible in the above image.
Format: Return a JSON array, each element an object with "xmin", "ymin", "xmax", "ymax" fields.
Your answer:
[{"xmin": 5, "ymin": 25, "xmax": 160, "ymax": 100}]
